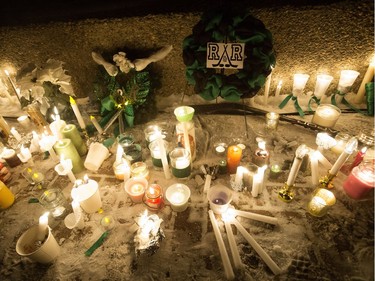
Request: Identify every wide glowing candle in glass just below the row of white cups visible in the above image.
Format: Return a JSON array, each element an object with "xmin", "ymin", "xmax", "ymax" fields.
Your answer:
[{"xmin": 311, "ymin": 104, "xmax": 341, "ymax": 128}]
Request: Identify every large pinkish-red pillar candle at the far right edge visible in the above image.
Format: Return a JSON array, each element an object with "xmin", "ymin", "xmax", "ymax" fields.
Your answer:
[{"xmin": 343, "ymin": 163, "xmax": 375, "ymax": 199}]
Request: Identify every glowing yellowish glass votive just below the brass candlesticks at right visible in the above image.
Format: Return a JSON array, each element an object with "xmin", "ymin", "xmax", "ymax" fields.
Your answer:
[{"xmin": 307, "ymin": 188, "xmax": 336, "ymax": 217}]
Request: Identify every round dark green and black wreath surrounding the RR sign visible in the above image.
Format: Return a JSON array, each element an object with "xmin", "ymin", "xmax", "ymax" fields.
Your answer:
[{"xmin": 183, "ymin": 11, "xmax": 276, "ymax": 101}]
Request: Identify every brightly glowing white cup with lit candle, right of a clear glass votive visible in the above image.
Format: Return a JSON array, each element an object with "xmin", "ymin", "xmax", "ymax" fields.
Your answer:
[{"xmin": 71, "ymin": 176, "xmax": 102, "ymax": 214}]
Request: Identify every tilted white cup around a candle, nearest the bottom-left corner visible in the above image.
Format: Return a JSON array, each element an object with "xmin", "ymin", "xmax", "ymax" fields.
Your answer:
[{"xmin": 16, "ymin": 225, "xmax": 60, "ymax": 263}]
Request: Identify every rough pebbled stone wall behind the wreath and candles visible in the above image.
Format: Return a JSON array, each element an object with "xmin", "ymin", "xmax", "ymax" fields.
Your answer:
[{"xmin": 0, "ymin": 0, "xmax": 374, "ymax": 107}]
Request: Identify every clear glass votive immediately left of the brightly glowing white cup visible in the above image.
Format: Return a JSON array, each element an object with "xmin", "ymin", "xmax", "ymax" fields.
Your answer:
[{"xmin": 39, "ymin": 188, "xmax": 67, "ymax": 218}]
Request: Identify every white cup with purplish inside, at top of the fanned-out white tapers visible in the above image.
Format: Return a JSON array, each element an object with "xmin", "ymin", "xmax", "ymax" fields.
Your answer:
[{"xmin": 207, "ymin": 185, "xmax": 233, "ymax": 214}]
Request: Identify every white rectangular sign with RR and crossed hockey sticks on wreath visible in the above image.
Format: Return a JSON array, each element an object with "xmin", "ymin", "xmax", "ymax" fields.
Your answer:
[{"xmin": 206, "ymin": 42, "xmax": 245, "ymax": 69}]
